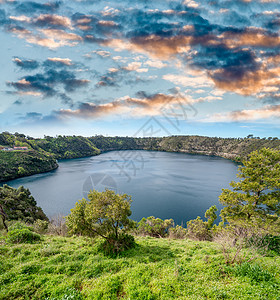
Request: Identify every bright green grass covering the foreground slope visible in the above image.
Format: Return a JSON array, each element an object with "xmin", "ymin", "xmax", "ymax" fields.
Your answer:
[{"xmin": 0, "ymin": 236, "xmax": 280, "ymax": 300}]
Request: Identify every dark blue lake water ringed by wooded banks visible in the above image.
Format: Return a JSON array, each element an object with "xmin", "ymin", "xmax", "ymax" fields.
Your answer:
[{"xmin": 2, "ymin": 151, "xmax": 238, "ymax": 225}]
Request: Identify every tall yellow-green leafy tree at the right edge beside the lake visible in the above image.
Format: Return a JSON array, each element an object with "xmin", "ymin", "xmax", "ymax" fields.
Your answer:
[{"xmin": 219, "ymin": 148, "xmax": 280, "ymax": 231}]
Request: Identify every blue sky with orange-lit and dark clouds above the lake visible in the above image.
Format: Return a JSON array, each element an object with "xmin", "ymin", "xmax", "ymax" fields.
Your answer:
[{"xmin": 0, "ymin": 0, "xmax": 280, "ymax": 137}]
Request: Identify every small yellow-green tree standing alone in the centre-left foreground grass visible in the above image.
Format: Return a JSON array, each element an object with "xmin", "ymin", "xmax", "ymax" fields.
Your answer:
[{"xmin": 66, "ymin": 189, "xmax": 134, "ymax": 252}]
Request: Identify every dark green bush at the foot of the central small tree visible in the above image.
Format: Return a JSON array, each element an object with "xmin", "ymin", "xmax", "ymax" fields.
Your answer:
[{"xmin": 99, "ymin": 233, "xmax": 136, "ymax": 256}]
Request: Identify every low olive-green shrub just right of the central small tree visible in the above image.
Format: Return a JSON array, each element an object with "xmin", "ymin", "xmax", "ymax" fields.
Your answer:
[{"xmin": 137, "ymin": 216, "xmax": 174, "ymax": 237}]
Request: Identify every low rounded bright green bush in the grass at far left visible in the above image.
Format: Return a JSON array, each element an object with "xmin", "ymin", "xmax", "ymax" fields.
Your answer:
[{"xmin": 6, "ymin": 226, "xmax": 41, "ymax": 244}]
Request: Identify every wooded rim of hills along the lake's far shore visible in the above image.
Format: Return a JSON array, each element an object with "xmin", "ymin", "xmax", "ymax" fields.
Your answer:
[{"xmin": 0, "ymin": 132, "xmax": 280, "ymax": 181}]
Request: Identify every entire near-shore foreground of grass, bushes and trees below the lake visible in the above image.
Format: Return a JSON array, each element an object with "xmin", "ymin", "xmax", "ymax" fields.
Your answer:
[{"xmin": 0, "ymin": 148, "xmax": 280, "ymax": 300}]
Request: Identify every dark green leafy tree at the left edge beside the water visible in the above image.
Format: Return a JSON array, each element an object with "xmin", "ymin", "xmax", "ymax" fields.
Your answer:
[{"xmin": 0, "ymin": 184, "xmax": 48, "ymax": 229}]
